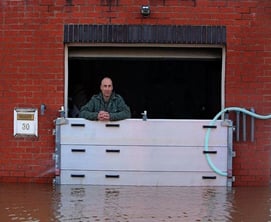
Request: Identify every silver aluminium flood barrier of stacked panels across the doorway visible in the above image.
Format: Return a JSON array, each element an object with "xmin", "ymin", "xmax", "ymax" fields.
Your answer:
[{"xmin": 55, "ymin": 117, "xmax": 233, "ymax": 186}]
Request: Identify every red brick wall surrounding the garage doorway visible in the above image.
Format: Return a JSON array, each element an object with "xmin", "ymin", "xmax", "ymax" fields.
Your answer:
[{"xmin": 0, "ymin": 0, "xmax": 271, "ymax": 186}]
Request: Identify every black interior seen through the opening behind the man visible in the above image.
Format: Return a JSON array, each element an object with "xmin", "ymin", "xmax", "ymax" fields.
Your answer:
[{"xmin": 68, "ymin": 57, "xmax": 222, "ymax": 119}]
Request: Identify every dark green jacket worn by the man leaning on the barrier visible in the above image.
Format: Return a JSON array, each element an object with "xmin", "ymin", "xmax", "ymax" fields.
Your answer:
[{"xmin": 79, "ymin": 92, "xmax": 131, "ymax": 121}]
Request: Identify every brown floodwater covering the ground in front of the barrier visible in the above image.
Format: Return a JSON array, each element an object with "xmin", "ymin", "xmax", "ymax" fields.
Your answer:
[{"xmin": 0, "ymin": 184, "xmax": 271, "ymax": 222}]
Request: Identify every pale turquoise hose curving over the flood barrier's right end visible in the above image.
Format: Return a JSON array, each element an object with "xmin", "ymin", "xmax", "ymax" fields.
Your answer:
[{"xmin": 204, "ymin": 107, "xmax": 271, "ymax": 176}]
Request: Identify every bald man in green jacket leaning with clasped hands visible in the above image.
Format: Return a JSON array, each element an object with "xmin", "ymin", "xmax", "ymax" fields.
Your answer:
[{"xmin": 79, "ymin": 77, "xmax": 131, "ymax": 121}]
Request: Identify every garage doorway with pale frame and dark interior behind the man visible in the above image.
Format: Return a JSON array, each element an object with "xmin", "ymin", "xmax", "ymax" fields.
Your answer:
[{"xmin": 65, "ymin": 44, "xmax": 225, "ymax": 119}]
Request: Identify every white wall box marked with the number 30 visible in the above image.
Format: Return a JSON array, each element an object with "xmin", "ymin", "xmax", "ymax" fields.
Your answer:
[{"xmin": 14, "ymin": 108, "xmax": 38, "ymax": 136}]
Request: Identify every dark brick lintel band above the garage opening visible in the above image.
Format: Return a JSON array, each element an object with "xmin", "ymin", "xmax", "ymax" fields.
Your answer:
[{"xmin": 64, "ymin": 24, "xmax": 226, "ymax": 45}]
